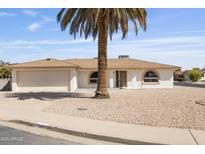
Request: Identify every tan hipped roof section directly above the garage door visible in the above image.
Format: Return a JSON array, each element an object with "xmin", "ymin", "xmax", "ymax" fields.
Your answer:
[{"xmin": 9, "ymin": 58, "xmax": 77, "ymax": 68}]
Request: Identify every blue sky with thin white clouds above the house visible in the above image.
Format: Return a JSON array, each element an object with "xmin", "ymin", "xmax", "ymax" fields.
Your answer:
[{"xmin": 0, "ymin": 8, "xmax": 205, "ymax": 70}]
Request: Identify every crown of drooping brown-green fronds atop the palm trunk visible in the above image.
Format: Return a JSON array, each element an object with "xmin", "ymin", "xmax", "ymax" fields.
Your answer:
[{"xmin": 57, "ymin": 8, "xmax": 147, "ymax": 40}]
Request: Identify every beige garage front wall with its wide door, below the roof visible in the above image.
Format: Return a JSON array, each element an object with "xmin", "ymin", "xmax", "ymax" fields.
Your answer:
[{"xmin": 12, "ymin": 68, "xmax": 72, "ymax": 92}]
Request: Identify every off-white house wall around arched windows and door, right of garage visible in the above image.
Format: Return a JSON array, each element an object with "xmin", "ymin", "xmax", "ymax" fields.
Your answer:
[{"xmin": 77, "ymin": 69, "xmax": 173, "ymax": 89}]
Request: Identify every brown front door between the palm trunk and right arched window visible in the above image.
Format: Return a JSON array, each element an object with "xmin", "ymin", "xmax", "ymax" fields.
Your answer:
[{"xmin": 116, "ymin": 71, "xmax": 127, "ymax": 87}]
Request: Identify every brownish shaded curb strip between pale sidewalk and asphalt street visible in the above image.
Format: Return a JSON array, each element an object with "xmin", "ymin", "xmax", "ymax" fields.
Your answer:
[{"xmin": 6, "ymin": 120, "xmax": 161, "ymax": 145}]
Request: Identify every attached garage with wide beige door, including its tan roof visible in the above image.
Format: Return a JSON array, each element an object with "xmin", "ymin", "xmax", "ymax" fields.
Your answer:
[{"xmin": 10, "ymin": 58, "xmax": 78, "ymax": 92}]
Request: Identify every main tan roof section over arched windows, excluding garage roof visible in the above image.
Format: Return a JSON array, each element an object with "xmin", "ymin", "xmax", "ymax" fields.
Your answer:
[{"xmin": 65, "ymin": 59, "xmax": 180, "ymax": 69}]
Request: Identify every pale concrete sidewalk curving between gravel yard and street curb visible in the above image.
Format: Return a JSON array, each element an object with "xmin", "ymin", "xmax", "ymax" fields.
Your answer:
[{"xmin": 0, "ymin": 100, "xmax": 205, "ymax": 145}]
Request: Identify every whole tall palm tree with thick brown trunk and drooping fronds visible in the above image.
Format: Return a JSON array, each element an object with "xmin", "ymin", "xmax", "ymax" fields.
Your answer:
[{"xmin": 57, "ymin": 8, "xmax": 147, "ymax": 98}]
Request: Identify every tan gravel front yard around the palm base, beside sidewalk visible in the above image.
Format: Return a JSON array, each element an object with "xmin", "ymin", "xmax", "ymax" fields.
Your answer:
[{"xmin": 42, "ymin": 86, "xmax": 205, "ymax": 130}]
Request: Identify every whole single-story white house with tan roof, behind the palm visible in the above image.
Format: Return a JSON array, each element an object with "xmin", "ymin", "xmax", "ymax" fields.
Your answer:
[{"xmin": 10, "ymin": 57, "xmax": 179, "ymax": 92}]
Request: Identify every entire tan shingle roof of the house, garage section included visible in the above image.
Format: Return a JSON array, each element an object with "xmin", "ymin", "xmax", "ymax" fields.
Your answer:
[{"xmin": 10, "ymin": 58, "xmax": 180, "ymax": 69}]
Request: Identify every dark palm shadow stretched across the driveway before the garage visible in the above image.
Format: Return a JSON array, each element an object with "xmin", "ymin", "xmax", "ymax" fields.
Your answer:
[{"xmin": 6, "ymin": 92, "xmax": 93, "ymax": 101}]
